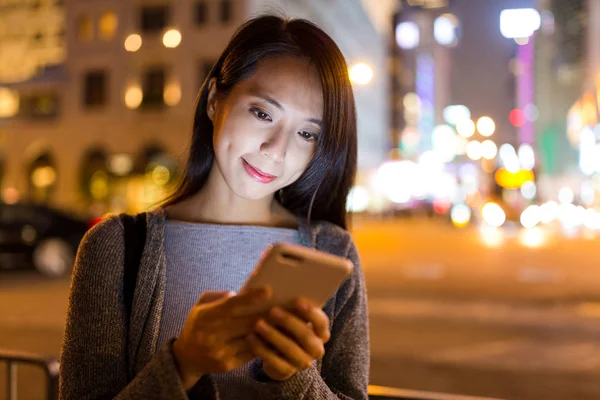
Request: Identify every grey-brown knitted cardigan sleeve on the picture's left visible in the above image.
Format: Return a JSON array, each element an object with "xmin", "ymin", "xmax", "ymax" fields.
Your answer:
[{"xmin": 59, "ymin": 217, "xmax": 216, "ymax": 400}]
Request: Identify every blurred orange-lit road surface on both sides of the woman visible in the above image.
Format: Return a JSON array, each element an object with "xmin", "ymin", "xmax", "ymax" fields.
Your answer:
[{"xmin": 0, "ymin": 219, "xmax": 600, "ymax": 400}]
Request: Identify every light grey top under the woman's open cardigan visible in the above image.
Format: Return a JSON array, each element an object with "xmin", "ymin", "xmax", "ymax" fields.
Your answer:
[{"xmin": 158, "ymin": 221, "xmax": 300, "ymax": 366}]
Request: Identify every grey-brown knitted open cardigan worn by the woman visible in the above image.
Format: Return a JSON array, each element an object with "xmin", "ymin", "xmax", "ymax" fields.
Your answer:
[{"xmin": 59, "ymin": 208, "xmax": 369, "ymax": 400}]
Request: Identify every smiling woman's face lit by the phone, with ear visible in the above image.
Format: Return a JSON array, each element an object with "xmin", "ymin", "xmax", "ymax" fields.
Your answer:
[{"xmin": 207, "ymin": 57, "xmax": 323, "ymax": 200}]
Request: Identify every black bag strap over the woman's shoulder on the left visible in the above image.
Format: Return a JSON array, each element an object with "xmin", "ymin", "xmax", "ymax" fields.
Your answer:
[{"xmin": 119, "ymin": 213, "xmax": 146, "ymax": 320}]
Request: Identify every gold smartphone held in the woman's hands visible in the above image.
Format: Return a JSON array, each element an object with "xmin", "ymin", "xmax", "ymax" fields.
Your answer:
[{"xmin": 241, "ymin": 243, "xmax": 354, "ymax": 308}]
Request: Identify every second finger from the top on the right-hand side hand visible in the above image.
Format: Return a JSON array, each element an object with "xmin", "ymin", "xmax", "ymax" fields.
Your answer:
[{"xmin": 269, "ymin": 307, "xmax": 325, "ymax": 360}]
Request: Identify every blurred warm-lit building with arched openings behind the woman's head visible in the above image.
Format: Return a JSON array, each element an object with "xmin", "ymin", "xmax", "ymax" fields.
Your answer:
[{"xmin": 0, "ymin": 0, "xmax": 388, "ymax": 214}]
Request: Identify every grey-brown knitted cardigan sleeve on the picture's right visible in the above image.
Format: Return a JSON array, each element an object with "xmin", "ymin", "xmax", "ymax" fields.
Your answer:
[{"xmin": 240, "ymin": 234, "xmax": 370, "ymax": 400}]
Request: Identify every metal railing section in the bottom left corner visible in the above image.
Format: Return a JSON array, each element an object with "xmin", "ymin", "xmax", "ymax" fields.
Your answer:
[{"xmin": 0, "ymin": 350, "xmax": 59, "ymax": 400}]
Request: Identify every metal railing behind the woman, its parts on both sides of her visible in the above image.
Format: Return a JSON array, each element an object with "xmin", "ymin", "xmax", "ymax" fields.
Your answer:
[{"xmin": 0, "ymin": 350, "xmax": 500, "ymax": 400}]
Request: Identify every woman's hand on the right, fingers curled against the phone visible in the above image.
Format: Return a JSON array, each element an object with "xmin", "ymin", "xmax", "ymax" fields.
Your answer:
[{"xmin": 248, "ymin": 299, "xmax": 331, "ymax": 381}]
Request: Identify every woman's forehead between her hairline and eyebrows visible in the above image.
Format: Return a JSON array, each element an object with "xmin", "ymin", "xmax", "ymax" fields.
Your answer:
[{"xmin": 237, "ymin": 57, "xmax": 323, "ymax": 117}]
